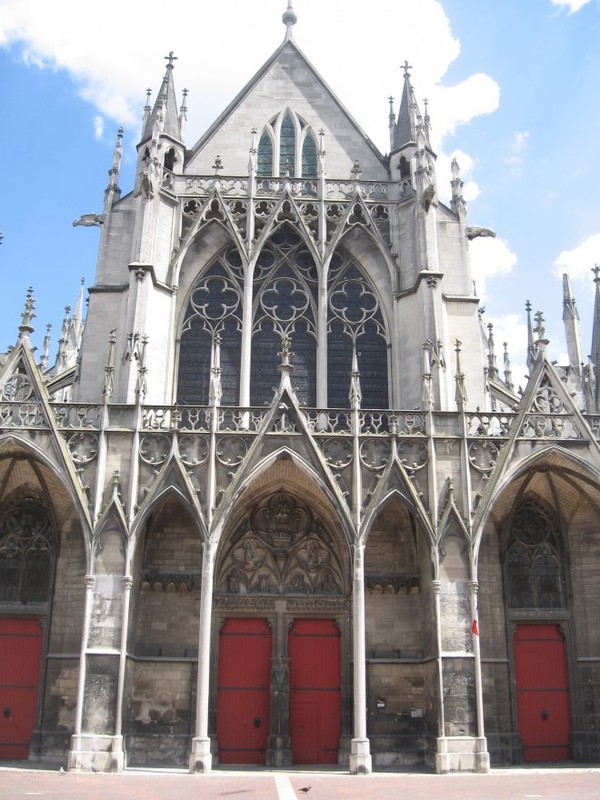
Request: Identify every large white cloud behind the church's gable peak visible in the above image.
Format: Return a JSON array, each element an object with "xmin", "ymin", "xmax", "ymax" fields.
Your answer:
[{"xmin": 0, "ymin": 0, "xmax": 499, "ymax": 162}]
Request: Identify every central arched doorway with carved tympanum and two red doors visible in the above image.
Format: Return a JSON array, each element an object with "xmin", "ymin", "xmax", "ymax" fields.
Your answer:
[{"xmin": 213, "ymin": 491, "xmax": 350, "ymax": 766}]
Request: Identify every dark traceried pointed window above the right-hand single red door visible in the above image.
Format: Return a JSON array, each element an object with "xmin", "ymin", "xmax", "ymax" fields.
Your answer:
[{"xmin": 505, "ymin": 502, "xmax": 565, "ymax": 609}]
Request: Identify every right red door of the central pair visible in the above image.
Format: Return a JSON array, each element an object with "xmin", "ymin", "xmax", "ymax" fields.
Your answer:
[{"xmin": 288, "ymin": 619, "xmax": 341, "ymax": 764}]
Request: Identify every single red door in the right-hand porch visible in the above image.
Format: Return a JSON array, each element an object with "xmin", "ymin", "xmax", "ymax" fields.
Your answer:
[{"xmin": 513, "ymin": 625, "xmax": 571, "ymax": 761}]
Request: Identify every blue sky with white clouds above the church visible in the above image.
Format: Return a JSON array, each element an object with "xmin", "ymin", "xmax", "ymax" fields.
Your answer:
[{"xmin": 0, "ymin": 0, "xmax": 600, "ymax": 383}]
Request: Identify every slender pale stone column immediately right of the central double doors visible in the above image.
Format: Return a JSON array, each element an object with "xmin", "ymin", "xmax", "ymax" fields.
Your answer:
[{"xmin": 350, "ymin": 544, "xmax": 373, "ymax": 775}]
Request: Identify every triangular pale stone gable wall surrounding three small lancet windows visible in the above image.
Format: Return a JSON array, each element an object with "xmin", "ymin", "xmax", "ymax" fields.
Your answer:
[{"xmin": 186, "ymin": 42, "xmax": 388, "ymax": 180}]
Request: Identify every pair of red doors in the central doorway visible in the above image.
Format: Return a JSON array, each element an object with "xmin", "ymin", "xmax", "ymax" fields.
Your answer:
[{"xmin": 217, "ymin": 618, "xmax": 341, "ymax": 764}]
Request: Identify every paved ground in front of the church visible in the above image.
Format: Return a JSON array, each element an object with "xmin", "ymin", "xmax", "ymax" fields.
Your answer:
[{"xmin": 0, "ymin": 767, "xmax": 600, "ymax": 800}]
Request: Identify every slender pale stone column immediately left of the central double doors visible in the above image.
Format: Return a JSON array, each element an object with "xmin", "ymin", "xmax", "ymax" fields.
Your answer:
[{"xmin": 190, "ymin": 542, "xmax": 215, "ymax": 772}]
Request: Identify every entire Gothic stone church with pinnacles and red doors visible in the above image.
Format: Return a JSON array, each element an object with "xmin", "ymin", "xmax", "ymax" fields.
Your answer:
[{"xmin": 0, "ymin": 4, "xmax": 600, "ymax": 774}]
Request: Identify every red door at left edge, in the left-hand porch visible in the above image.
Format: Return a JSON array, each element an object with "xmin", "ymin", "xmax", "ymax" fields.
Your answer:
[{"xmin": 0, "ymin": 619, "xmax": 42, "ymax": 759}]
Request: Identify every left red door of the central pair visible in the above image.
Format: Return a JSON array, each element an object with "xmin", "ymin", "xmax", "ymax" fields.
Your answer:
[{"xmin": 217, "ymin": 619, "xmax": 271, "ymax": 764}]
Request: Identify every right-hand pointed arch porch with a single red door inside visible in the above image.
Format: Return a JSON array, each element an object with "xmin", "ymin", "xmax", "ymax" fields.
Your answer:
[{"xmin": 477, "ymin": 445, "xmax": 600, "ymax": 763}]
